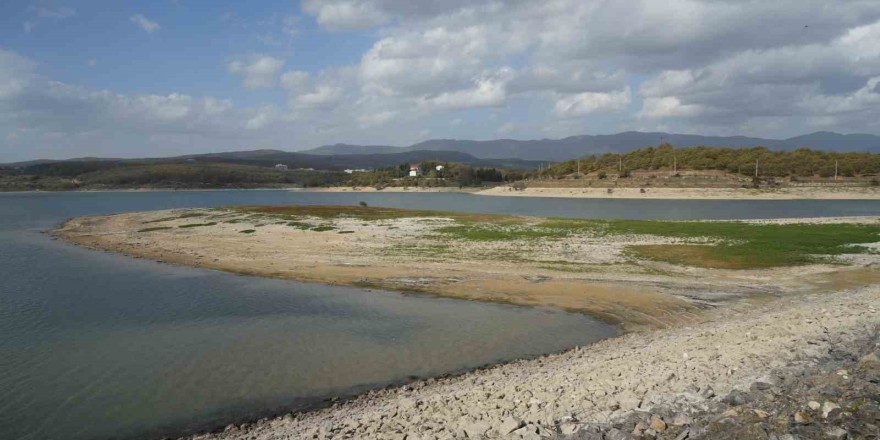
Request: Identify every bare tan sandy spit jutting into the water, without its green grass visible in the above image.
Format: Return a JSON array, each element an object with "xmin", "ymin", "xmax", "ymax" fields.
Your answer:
[{"xmin": 56, "ymin": 210, "xmax": 880, "ymax": 331}]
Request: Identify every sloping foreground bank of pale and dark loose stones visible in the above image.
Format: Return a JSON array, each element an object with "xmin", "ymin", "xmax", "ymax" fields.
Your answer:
[{"xmin": 182, "ymin": 286, "xmax": 880, "ymax": 440}]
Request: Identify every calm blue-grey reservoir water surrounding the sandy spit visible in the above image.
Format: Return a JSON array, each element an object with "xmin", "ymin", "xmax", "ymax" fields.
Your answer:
[{"xmin": 0, "ymin": 191, "xmax": 880, "ymax": 440}]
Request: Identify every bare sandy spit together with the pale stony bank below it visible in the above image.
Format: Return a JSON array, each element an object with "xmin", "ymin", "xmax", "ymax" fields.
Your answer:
[{"xmin": 53, "ymin": 207, "xmax": 880, "ymax": 440}]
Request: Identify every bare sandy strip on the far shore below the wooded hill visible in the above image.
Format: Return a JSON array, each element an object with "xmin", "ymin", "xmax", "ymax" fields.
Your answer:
[{"xmin": 476, "ymin": 186, "xmax": 880, "ymax": 200}]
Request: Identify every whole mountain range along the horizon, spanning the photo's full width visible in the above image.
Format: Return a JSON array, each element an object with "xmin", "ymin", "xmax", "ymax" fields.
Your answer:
[{"xmin": 0, "ymin": 131, "xmax": 880, "ymax": 170}]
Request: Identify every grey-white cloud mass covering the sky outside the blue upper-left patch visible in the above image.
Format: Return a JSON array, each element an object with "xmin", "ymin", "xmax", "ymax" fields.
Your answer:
[{"xmin": 8, "ymin": 0, "xmax": 880, "ymax": 162}]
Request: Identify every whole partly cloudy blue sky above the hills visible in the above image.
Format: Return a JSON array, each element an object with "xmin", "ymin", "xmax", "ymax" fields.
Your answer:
[{"xmin": 0, "ymin": 0, "xmax": 880, "ymax": 162}]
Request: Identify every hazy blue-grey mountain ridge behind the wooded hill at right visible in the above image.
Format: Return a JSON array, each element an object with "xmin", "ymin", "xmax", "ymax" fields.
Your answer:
[{"xmin": 302, "ymin": 131, "xmax": 880, "ymax": 162}]
